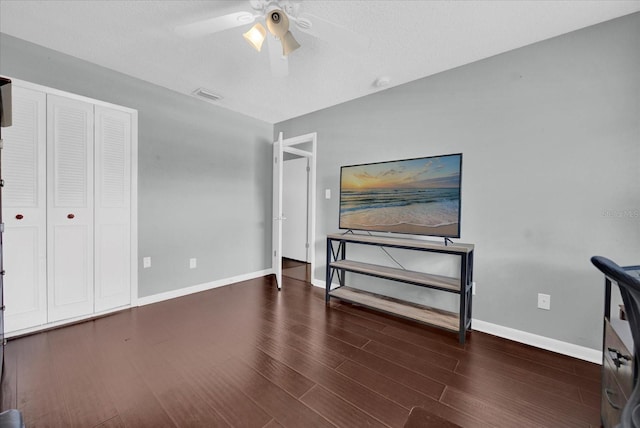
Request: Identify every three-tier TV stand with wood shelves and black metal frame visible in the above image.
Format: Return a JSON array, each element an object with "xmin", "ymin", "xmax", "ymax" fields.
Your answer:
[{"xmin": 325, "ymin": 234, "xmax": 474, "ymax": 344}]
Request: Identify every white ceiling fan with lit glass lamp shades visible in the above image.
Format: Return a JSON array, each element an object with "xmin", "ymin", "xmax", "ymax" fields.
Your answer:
[{"xmin": 175, "ymin": 0, "xmax": 369, "ymax": 77}]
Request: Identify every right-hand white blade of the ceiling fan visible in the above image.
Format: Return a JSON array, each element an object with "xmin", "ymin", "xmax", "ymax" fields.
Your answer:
[{"xmin": 291, "ymin": 13, "xmax": 371, "ymax": 53}]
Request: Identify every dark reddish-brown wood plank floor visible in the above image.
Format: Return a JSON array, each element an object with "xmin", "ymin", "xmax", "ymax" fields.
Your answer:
[{"xmin": 2, "ymin": 260, "xmax": 600, "ymax": 428}]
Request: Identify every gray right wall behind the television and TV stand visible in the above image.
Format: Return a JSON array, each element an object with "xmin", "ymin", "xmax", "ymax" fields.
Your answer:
[{"xmin": 274, "ymin": 14, "xmax": 640, "ymax": 349}]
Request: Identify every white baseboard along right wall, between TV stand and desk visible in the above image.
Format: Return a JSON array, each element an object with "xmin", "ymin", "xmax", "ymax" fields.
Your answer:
[{"xmin": 471, "ymin": 319, "xmax": 602, "ymax": 364}]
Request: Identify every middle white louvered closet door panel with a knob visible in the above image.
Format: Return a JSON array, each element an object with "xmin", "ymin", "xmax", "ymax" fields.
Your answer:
[{"xmin": 47, "ymin": 95, "xmax": 94, "ymax": 322}]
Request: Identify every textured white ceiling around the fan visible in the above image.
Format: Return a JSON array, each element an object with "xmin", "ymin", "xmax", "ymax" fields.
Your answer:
[{"xmin": 0, "ymin": 0, "xmax": 640, "ymax": 123}]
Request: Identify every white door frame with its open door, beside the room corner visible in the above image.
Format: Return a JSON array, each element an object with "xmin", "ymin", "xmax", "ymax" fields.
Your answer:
[{"xmin": 271, "ymin": 132, "xmax": 318, "ymax": 290}]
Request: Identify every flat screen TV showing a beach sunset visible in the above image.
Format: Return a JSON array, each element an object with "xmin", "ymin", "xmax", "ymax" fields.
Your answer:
[{"xmin": 340, "ymin": 153, "xmax": 462, "ymax": 238}]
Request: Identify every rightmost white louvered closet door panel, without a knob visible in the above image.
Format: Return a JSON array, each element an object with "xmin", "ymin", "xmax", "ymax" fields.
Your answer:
[{"xmin": 95, "ymin": 106, "xmax": 132, "ymax": 312}]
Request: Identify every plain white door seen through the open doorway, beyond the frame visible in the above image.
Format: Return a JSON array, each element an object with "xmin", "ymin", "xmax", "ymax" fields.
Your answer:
[{"xmin": 282, "ymin": 157, "xmax": 309, "ymax": 262}]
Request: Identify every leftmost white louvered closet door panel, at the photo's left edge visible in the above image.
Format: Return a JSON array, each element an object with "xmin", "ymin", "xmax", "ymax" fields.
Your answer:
[{"xmin": 2, "ymin": 86, "xmax": 47, "ymax": 333}]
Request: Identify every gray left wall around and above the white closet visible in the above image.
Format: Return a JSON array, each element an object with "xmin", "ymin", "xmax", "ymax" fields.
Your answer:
[{"xmin": 0, "ymin": 34, "xmax": 273, "ymax": 297}]
